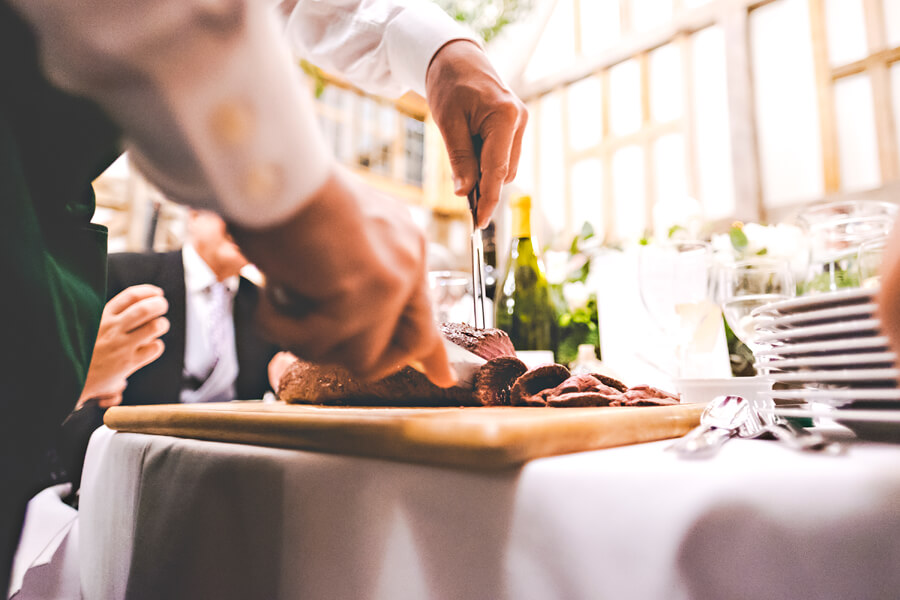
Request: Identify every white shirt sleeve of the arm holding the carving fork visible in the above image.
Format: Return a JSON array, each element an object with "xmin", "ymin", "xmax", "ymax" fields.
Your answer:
[{"xmin": 282, "ymin": 0, "xmax": 479, "ymax": 97}]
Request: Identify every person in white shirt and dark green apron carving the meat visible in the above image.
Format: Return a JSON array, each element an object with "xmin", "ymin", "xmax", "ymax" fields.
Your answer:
[{"xmin": 0, "ymin": 0, "xmax": 527, "ymax": 588}]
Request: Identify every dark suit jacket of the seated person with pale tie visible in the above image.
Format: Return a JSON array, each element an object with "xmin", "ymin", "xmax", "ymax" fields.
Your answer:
[{"xmin": 107, "ymin": 250, "xmax": 278, "ymax": 405}]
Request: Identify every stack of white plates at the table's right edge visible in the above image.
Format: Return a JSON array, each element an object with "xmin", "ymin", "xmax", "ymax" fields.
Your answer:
[{"xmin": 751, "ymin": 288, "xmax": 900, "ymax": 437}]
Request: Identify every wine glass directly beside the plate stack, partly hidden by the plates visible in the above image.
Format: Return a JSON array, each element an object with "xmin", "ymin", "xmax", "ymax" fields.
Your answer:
[{"xmin": 719, "ymin": 257, "xmax": 796, "ymax": 354}]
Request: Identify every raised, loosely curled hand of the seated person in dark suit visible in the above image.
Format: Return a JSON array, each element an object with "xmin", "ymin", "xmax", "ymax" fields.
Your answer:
[{"xmin": 76, "ymin": 285, "xmax": 169, "ymax": 408}]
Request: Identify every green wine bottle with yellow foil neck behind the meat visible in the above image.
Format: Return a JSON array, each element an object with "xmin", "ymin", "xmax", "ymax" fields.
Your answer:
[{"xmin": 494, "ymin": 196, "xmax": 556, "ymax": 351}]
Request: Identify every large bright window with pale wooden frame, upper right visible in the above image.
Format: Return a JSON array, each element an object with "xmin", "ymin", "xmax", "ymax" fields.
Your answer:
[{"xmin": 514, "ymin": 0, "xmax": 900, "ymax": 241}]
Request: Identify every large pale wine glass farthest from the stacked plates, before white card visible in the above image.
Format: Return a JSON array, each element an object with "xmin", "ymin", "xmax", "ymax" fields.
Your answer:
[{"xmin": 638, "ymin": 241, "xmax": 722, "ymax": 377}]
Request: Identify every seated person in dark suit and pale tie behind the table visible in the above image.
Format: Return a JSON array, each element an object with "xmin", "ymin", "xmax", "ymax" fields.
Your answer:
[{"xmin": 49, "ymin": 210, "xmax": 293, "ymax": 489}]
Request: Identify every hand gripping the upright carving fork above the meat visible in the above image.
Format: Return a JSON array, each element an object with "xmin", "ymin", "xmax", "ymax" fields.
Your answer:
[{"xmin": 425, "ymin": 40, "xmax": 528, "ymax": 227}]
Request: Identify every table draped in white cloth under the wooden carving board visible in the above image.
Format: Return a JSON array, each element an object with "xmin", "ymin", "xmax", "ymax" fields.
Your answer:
[{"xmin": 80, "ymin": 428, "xmax": 900, "ymax": 600}]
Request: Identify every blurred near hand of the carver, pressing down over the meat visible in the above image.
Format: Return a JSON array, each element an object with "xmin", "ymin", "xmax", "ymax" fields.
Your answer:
[{"xmin": 233, "ymin": 171, "xmax": 455, "ymax": 386}]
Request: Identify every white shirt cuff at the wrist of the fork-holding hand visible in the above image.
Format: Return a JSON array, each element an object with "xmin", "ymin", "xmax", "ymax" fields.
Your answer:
[{"xmin": 385, "ymin": 2, "xmax": 483, "ymax": 97}]
